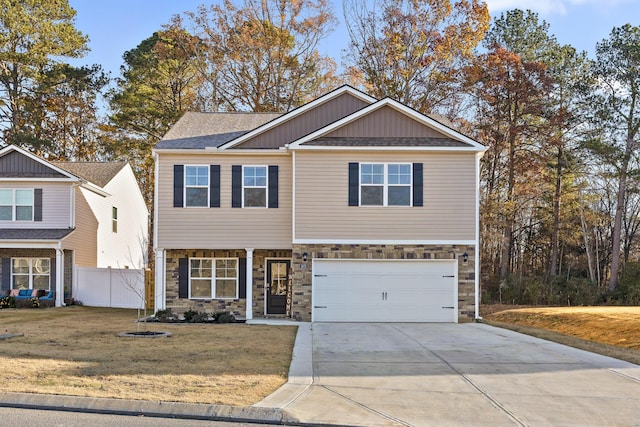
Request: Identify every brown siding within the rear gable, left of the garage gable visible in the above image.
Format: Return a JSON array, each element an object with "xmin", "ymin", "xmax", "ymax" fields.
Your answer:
[{"xmin": 236, "ymin": 93, "xmax": 368, "ymax": 148}]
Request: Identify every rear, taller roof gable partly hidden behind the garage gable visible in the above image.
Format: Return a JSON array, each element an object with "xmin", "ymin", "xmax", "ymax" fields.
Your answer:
[{"xmin": 219, "ymin": 85, "xmax": 376, "ymax": 150}]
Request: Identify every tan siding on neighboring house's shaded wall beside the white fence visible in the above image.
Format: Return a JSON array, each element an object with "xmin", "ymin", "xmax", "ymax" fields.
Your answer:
[{"xmin": 64, "ymin": 188, "xmax": 98, "ymax": 267}]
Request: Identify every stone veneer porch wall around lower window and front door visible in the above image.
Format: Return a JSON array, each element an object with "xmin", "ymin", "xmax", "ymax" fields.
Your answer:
[{"xmin": 166, "ymin": 249, "xmax": 291, "ymax": 317}]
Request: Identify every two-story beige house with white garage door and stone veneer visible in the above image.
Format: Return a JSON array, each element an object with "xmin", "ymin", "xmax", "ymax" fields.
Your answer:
[{"xmin": 154, "ymin": 86, "xmax": 485, "ymax": 322}]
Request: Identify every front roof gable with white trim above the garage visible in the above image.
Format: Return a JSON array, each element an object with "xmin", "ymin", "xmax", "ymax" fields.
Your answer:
[{"xmin": 289, "ymin": 98, "xmax": 486, "ymax": 152}]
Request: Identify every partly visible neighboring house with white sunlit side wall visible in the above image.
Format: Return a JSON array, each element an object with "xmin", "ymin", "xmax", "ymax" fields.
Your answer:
[{"xmin": 0, "ymin": 146, "xmax": 148, "ymax": 306}]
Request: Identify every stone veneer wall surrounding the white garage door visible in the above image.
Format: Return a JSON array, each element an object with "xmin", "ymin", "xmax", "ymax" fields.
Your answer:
[{"xmin": 291, "ymin": 244, "xmax": 475, "ymax": 322}]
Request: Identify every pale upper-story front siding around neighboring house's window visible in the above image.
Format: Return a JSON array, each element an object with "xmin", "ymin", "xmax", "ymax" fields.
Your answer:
[{"xmin": 0, "ymin": 181, "xmax": 71, "ymax": 228}]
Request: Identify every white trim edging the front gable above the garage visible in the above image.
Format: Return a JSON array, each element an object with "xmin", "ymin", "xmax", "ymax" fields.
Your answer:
[{"xmin": 287, "ymin": 98, "xmax": 487, "ymax": 151}]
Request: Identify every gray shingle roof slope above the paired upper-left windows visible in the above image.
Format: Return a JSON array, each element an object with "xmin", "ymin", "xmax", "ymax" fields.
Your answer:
[{"xmin": 155, "ymin": 112, "xmax": 281, "ymax": 149}]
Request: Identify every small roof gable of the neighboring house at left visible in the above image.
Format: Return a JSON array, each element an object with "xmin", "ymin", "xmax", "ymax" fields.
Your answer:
[{"xmin": 0, "ymin": 145, "xmax": 77, "ymax": 180}]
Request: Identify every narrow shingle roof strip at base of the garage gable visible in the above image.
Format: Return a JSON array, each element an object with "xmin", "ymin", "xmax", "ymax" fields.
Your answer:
[{"xmin": 303, "ymin": 137, "xmax": 469, "ymax": 147}]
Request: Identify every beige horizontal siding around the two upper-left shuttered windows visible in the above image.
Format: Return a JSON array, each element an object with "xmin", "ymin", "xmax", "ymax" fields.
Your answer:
[{"xmin": 157, "ymin": 153, "xmax": 292, "ymax": 249}]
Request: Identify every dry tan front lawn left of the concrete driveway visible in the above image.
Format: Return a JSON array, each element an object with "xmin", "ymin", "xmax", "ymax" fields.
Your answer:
[{"xmin": 0, "ymin": 307, "xmax": 296, "ymax": 405}]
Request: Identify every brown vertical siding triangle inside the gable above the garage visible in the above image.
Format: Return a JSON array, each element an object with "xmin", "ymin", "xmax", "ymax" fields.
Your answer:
[{"xmin": 325, "ymin": 106, "xmax": 444, "ymax": 138}]
